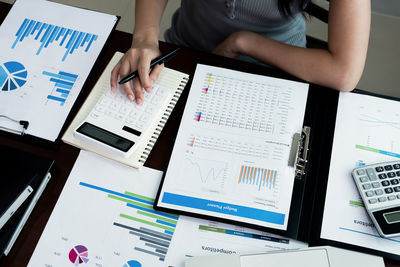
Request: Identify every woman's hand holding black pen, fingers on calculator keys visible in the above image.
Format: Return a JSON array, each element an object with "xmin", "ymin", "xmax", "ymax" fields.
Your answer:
[{"xmin": 111, "ymin": 42, "xmax": 164, "ymax": 105}]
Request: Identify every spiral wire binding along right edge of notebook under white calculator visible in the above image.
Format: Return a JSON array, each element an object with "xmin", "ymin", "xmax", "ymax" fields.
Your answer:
[{"xmin": 139, "ymin": 77, "xmax": 189, "ymax": 164}]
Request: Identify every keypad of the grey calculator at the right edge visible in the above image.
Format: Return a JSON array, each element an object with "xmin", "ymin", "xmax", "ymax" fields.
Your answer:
[{"xmin": 354, "ymin": 163, "xmax": 400, "ymax": 207}]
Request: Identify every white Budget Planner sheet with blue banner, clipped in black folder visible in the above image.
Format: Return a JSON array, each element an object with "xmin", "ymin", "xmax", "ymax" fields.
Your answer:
[{"xmin": 158, "ymin": 65, "xmax": 308, "ymax": 229}]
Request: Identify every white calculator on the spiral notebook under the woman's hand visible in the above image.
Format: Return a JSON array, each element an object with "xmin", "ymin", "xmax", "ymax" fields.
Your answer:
[{"xmin": 74, "ymin": 84, "xmax": 170, "ymax": 158}]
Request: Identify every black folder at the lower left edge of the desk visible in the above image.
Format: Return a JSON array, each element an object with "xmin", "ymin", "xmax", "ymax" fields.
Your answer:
[{"xmin": 0, "ymin": 146, "xmax": 54, "ymax": 257}]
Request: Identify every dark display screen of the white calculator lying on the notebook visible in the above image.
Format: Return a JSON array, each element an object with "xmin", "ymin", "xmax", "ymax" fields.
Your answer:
[{"xmin": 77, "ymin": 122, "xmax": 135, "ymax": 152}]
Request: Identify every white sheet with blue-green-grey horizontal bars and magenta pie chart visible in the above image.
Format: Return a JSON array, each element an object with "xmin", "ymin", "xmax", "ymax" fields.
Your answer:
[{"xmin": 29, "ymin": 151, "xmax": 170, "ymax": 267}]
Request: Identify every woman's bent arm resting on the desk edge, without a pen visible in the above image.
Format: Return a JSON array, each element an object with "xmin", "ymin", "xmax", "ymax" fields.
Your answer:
[{"xmin": 214, "ymin": 0, "xmax": 371, "ymax": 91}]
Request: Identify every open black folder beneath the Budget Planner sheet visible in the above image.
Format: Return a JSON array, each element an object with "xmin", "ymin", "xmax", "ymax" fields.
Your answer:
[{"xmin": 154, "ymin": 62, "xmax": 400, "ymax": 260}]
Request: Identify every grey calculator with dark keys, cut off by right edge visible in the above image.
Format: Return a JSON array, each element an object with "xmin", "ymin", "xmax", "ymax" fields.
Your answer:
[{"xmin": 352, "ymin": 160, "xmax": 400, "ymax": 237}]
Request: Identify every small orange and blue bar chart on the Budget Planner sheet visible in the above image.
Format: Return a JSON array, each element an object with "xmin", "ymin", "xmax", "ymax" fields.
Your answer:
[{"xmin": 238, "ymin": 165, "xmax": 277, "ymax": 191}]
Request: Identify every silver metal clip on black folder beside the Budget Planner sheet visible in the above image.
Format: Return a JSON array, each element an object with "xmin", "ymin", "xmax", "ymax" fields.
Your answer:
[{"xmin": 289, "ymin": 126, "xmax": 311, "ymax": 179}]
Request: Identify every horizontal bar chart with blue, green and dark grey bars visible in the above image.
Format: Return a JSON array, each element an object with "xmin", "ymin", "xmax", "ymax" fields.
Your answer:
[{"xmin": 79, "ymin": 182, "xmax": 178, "ymax": 261}]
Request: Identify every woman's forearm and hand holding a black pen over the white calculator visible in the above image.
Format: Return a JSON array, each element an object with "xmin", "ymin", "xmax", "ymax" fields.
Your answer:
[{"xmin": 111, "ymin": 0, "xmax": 168, "ymax": 104}]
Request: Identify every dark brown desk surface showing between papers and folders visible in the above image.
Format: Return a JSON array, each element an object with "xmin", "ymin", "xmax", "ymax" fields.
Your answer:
[{"xmin": 0, "ymin": 2, "xmax": 400, "ymax": 267}]
